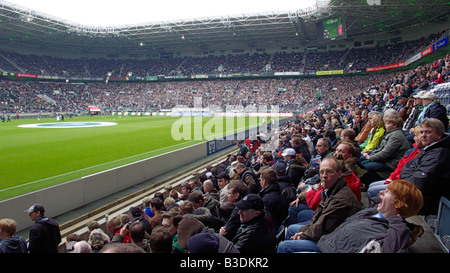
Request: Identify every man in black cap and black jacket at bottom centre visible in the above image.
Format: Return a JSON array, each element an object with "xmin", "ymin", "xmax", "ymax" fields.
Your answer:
[{"xmin": 233, "ymin": 193, "xmax": 275, "ymax": 253}]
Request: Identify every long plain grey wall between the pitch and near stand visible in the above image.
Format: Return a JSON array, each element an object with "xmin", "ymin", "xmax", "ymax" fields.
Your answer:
[{"xmin": 0, "ymin": 142, "xmax": 208, "ymax": 231}]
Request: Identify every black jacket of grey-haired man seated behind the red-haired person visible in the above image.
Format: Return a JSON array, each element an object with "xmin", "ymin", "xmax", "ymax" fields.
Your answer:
[{"xmin": 400, "ymin": 134, "xmax": 450, "ymax": 215}]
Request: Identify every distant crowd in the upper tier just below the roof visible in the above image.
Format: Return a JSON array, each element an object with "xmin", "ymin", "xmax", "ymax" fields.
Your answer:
[{"xmin": 0, "ymin": 30, "xmax": 446, "ymax": 78}]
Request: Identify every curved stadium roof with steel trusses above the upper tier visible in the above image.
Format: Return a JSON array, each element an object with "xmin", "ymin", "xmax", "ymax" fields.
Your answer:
[{"xmin": 0, "ymin": 0, "xmax": 450, "ymax": 53}]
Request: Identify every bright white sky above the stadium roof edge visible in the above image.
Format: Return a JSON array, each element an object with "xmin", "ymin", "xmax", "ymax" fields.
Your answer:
[{"xmin": 6, "ymin": 0, "xmax": 316, "ymax": 27}]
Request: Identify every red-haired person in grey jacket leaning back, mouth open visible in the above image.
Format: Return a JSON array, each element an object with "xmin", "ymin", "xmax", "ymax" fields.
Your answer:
[{"xmin": 317, "ymin": 180, "xmax": 423, "ymax": 253}]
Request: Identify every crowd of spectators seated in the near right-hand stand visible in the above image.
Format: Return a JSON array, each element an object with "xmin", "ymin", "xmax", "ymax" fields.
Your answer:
[{"xmin": 0, "ymin": 49, "xmax": 450, "ymax": 253}]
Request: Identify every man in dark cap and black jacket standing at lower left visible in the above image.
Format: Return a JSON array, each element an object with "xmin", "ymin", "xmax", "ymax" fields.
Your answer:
[{"xmin": 25, "ymin": 204, "xmax": 61, "ymax": 253}]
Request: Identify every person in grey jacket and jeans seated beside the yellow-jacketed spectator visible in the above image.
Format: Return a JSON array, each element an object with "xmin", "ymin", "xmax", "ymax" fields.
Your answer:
[{"xmin": 361, "ymin": 116, "xmax": 409, "ymax": 186}]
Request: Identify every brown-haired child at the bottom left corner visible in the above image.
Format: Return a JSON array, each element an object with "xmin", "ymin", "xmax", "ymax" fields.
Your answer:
[{"xmin": 0, "ymin": 218, "xmax": 28, "ymax": 253}]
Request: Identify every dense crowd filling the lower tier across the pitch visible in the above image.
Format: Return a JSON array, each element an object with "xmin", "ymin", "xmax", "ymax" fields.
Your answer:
[{"xmin": 0, "ymin": 68, "xmax": 448, "ymax": 114}]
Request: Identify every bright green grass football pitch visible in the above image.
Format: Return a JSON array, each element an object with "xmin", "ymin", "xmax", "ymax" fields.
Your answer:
[{"xmin": 0, "ymin": 113, "xmax": 268, "ymax": 200}]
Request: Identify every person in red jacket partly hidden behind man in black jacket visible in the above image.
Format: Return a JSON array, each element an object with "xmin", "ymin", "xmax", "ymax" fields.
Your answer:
[{"xmin": 367, "ymin": 126, "xmax": 423, "ymax": 202}]
